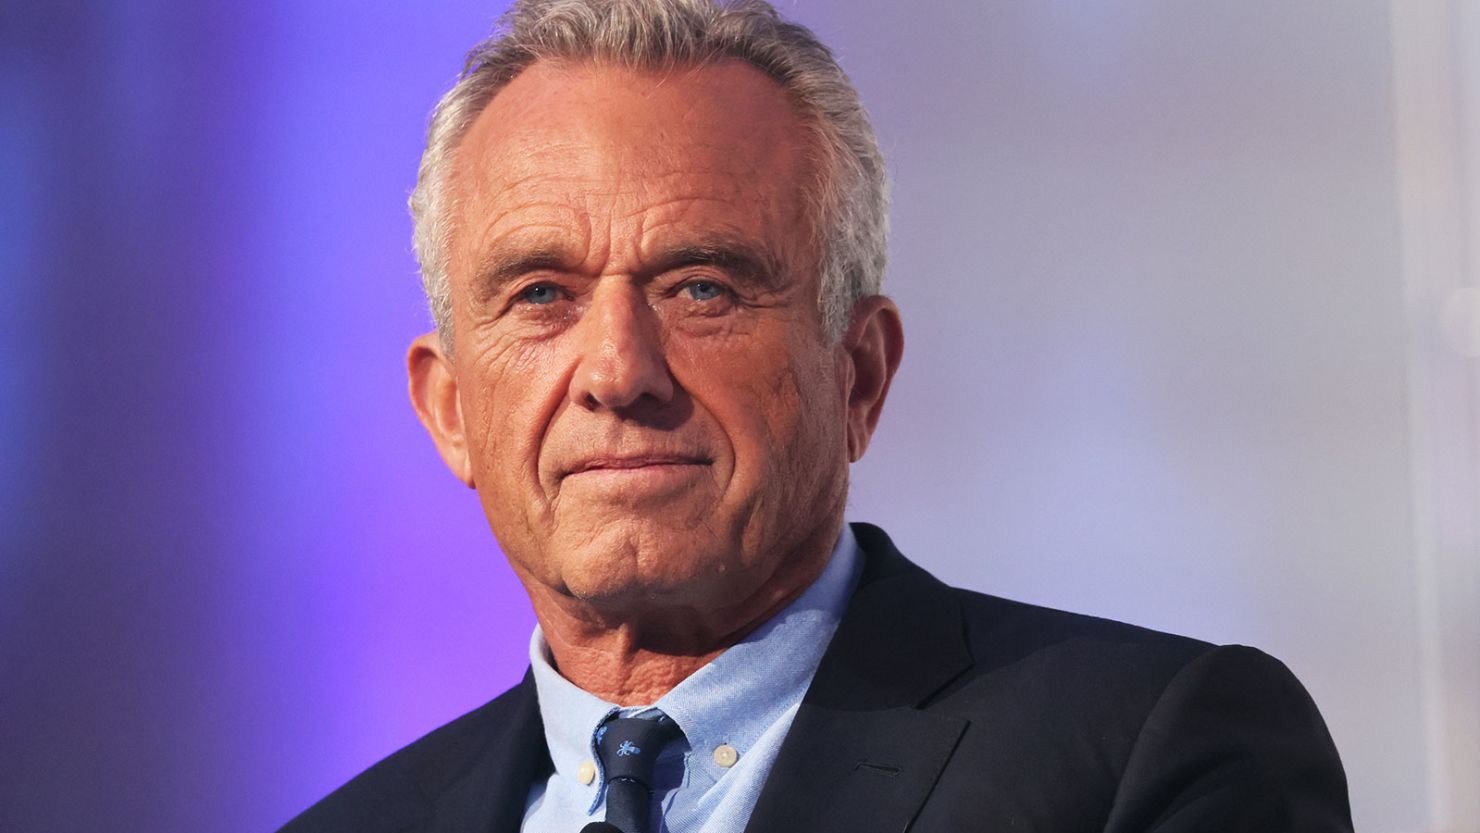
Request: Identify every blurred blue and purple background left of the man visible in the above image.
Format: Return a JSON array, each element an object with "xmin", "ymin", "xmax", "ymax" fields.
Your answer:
[{"xmin": 0, "ymin": 0, "xmax": 533, "ymax": 833}]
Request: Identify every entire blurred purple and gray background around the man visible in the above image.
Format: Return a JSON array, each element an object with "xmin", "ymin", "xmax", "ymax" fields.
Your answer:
[{"xmin": 0, "ymin": 0, "xmax": 1480, "ymax": 833}]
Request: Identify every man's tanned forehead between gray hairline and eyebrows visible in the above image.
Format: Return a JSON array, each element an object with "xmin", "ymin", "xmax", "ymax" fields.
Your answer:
[{"xmin": 451, "ymin": 61, "xmax": 811, "ymax": 272}]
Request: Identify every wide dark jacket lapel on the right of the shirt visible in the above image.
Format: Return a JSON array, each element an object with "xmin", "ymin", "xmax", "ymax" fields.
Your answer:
[{"xmin": 746, "ymin": 524, "xmax": 972, "ymax": 833}]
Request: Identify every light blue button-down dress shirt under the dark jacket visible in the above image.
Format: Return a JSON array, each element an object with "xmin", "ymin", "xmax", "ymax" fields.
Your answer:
[{"xmin": 522, "ymin": 524, "xmax": 863, "ymax": 833}]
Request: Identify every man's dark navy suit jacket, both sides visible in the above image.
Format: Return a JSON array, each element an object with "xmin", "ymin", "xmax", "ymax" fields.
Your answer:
[{"xmin": 283, "ymin": 524, "xmax": 1351, "ymax": 833}]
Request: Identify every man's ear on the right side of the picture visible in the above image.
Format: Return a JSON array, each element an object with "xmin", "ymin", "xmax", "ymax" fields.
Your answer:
[{"xmin": 842, "ymin": 294, "xmax": 904, "ymax": 463}]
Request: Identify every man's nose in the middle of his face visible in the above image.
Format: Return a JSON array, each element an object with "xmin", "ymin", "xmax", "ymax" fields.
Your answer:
[{"xmin": 570, "ymin": 284, "xmax": 673, "ymax": 410}]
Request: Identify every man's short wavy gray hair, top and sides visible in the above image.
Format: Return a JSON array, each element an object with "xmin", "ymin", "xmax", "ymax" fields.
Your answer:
[{"xmin": 410, "ymin": 0, "xmax": 888, "ymax": 351}]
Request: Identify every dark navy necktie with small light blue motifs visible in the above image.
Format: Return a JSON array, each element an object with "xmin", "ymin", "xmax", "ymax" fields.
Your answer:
[{"xmin": 596, "ymin": 712, "xmax": 684, "ymax": 833}]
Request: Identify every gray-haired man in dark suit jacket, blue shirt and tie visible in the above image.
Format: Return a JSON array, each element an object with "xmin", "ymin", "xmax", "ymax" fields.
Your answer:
[{"xmin": 286, "ymin": 0, "xmax": 1350, "ymax": 833}]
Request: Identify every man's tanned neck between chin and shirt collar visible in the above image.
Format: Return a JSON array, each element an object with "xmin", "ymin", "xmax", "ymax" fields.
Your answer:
[{"xmin": 525, "ymin": 522, "xmax": 841, "ymax": 706}]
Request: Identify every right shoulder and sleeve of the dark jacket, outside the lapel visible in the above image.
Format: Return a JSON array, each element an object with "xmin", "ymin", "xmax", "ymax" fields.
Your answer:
[{"xmin": 922, "ymin": 589, "xmax": 1351, "ymax": 832}]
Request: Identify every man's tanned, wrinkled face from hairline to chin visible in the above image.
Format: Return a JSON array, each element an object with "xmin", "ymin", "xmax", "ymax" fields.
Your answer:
[{"xmin": 413, "ymin": 62, "xmax": 861, "ymax": 610}]
